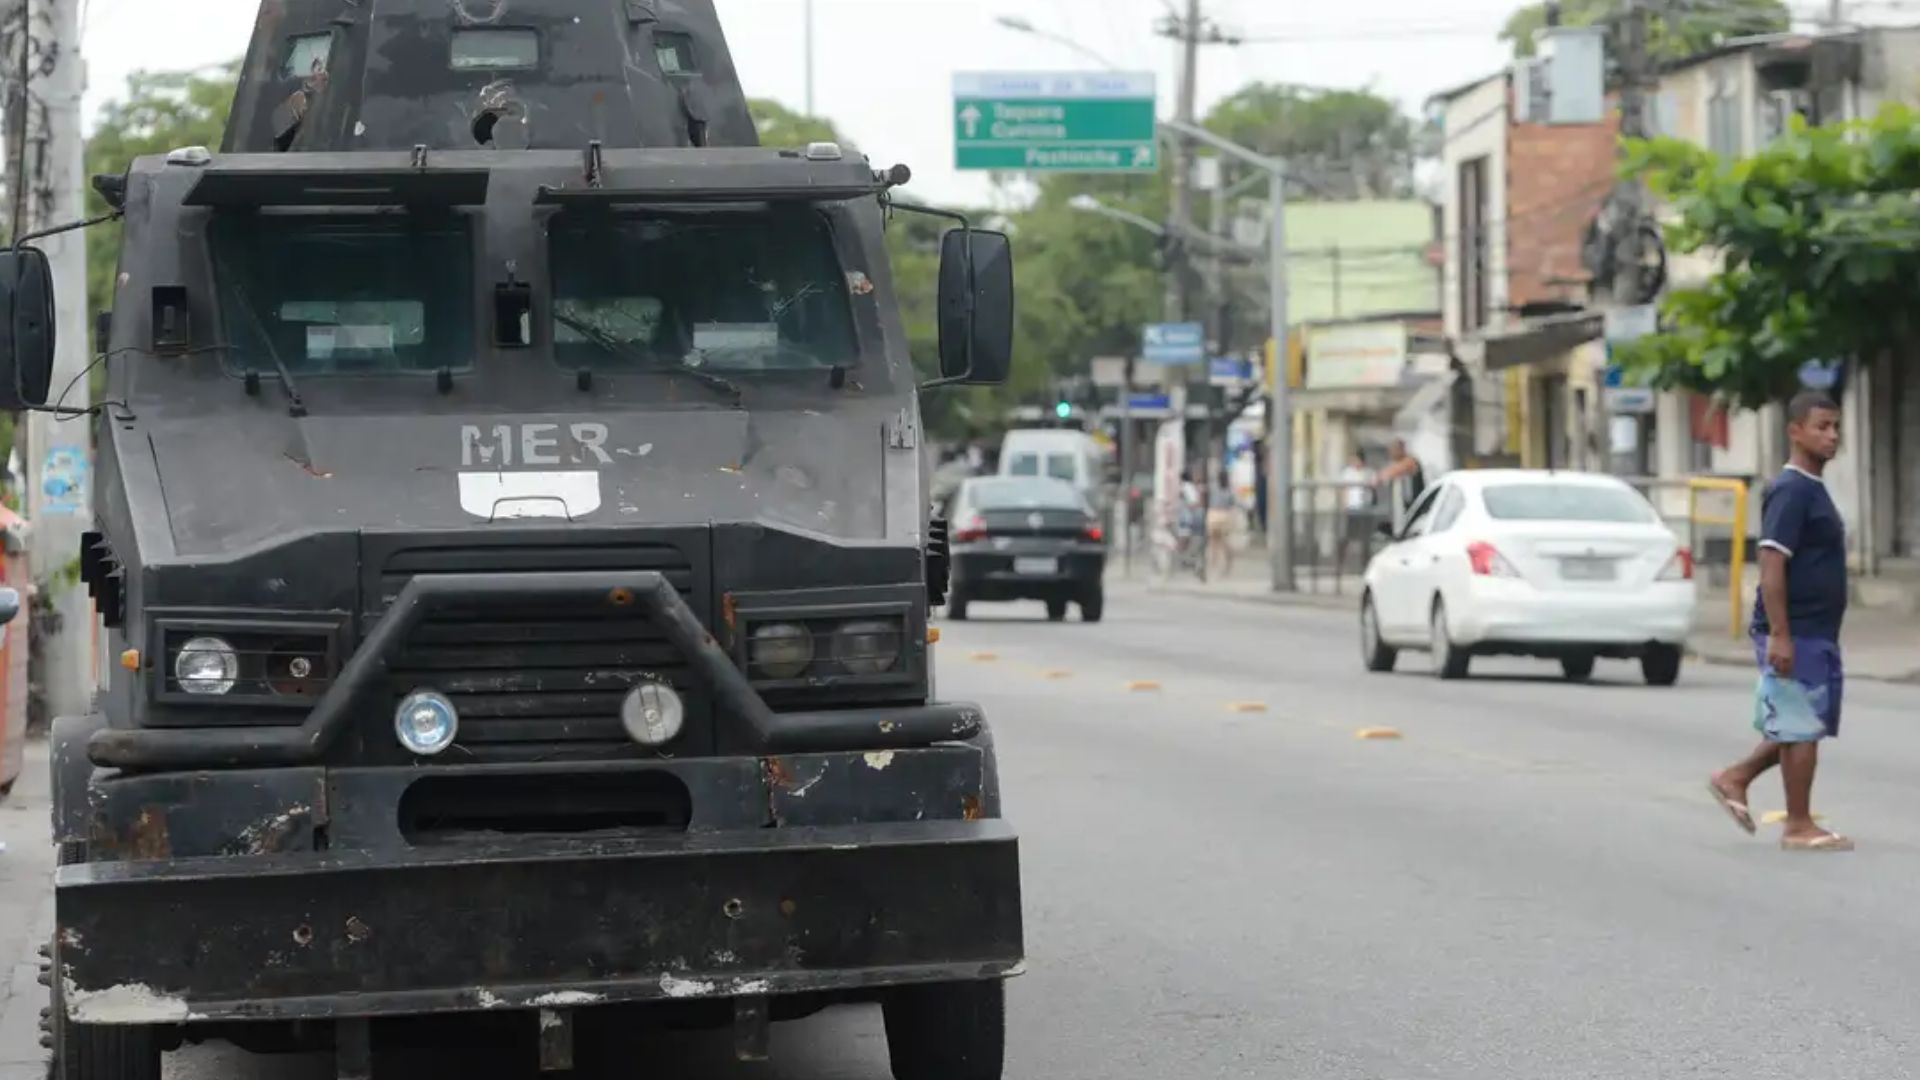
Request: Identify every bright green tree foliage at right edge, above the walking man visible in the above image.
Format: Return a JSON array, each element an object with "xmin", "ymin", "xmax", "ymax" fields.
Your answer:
[{"xmin": 1622, "ymin": 106, "xmax": 1920, "ymax": 407}]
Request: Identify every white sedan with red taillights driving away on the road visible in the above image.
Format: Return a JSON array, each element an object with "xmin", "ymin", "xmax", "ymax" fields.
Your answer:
[{"xmin": 1359, "ymin": 469, "xmax": 1693, "ymax": 686}]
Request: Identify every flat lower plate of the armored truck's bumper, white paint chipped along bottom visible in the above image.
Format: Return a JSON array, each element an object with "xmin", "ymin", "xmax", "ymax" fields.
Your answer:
[{"xmin": 56, "ymin": 821, "xmax": 1021, "ymax": 1024}]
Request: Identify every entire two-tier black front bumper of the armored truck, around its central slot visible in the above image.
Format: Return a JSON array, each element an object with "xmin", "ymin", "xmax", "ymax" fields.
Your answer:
[{"xmin": 54, "ymin": 746, "xmax": 1023, "ymax": 1024}]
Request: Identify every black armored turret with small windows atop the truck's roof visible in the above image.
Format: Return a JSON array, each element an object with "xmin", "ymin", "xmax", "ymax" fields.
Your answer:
[{"xmin": 223, "ymin": 0, "xmax": 758, "ymax": 154}]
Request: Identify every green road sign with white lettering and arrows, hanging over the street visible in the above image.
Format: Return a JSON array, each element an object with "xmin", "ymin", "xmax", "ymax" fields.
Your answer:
[{"xmin": 954, "ymin": 71, "xmax": 1160, "ymax": 173}]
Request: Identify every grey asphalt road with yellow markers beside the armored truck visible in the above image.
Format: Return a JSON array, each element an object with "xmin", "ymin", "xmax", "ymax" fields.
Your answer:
[{"xmin": 0, "ymin": 580, "xmax": 1920, "ymax": 1080}]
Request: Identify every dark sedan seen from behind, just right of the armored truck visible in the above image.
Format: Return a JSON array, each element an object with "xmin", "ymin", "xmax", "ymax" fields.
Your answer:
[{"xmin": 947, "ymin": 477, "xmax": 1106, "ymax": 623}]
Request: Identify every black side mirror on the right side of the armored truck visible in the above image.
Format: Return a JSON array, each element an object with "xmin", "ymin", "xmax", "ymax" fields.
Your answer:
[{"xmin": 939, "ymin": 229, "xmax": 1014, "ymax": 386}]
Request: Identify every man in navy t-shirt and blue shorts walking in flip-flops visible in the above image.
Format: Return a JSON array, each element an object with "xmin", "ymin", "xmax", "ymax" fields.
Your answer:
[{"xmin": 1709, "ymin": 392, "xmax": 1853, "ymax": 851}]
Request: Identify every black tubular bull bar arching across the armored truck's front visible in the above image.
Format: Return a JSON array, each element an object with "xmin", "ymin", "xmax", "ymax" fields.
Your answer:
[{"xmin": 88, "ymin": 571, "xmax": 981, "ymax": 769}]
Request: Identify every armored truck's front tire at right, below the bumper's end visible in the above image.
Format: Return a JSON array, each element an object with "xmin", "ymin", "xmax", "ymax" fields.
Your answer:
[{"xmin": 881, "ymin": 980, "xmax": 1006, "ymax": 1080}]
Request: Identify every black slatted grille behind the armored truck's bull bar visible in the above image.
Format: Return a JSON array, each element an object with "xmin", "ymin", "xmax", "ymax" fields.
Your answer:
[{"xmin": 380, "ymin": 544, "xmax": 707, "ymax": 746}]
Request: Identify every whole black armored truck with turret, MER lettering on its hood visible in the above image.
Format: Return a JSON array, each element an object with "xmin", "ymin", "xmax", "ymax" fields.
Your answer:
[{"xmin": 0, "ymin": 0, "xmax": 1023, "ymax": 1080}]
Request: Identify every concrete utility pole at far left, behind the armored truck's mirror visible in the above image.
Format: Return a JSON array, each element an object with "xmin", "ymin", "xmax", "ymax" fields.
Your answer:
[{"xmin": 6, "ymin": 0, "xmax": 98, "ymax": 717}]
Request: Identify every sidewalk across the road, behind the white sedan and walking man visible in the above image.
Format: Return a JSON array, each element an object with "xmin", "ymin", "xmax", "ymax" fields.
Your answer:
[{"xmin": 1108, "ymin": 550, "xmax": 1920, "ymax": 684}]
